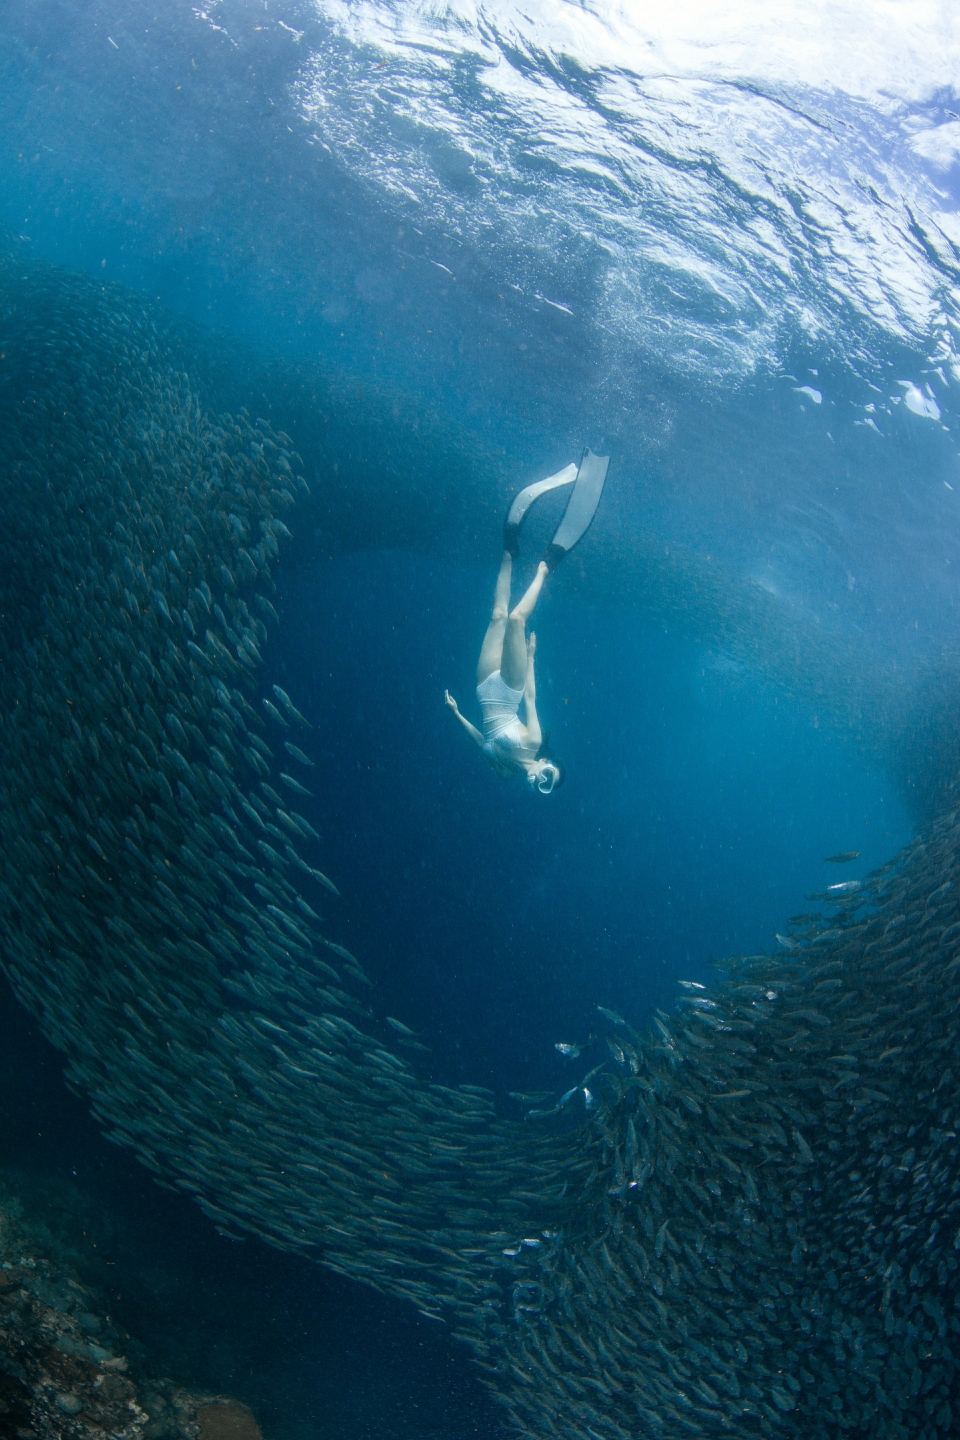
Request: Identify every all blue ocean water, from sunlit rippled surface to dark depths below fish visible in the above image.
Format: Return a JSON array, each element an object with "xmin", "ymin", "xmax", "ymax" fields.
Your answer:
[{"xmin": 0, "ymin": 0, "xmax": 960, "ymax": 1440}]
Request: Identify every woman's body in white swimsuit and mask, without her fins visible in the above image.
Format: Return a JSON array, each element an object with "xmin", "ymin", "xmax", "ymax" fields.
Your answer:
[{"xmin": 443, "ymin": 550, "xmax": 564, "ymax": 795}]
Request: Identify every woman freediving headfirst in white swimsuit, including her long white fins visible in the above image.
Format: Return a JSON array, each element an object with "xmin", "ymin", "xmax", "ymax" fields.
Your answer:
[{"xmin": 443, "ymin": 451, "xmax": 609, "ymax": 795}]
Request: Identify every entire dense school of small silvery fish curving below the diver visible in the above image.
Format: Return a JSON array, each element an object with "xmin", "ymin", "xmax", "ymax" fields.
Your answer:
[{"xmin": 0, "ymin": 241, "xmax": 960, "ymax": 1440}]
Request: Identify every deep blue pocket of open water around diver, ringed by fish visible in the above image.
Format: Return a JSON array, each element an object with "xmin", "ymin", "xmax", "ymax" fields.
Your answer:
[{"xmin": 269, "ymin": 540, "xmax": 911, "ymax": 1092}]
